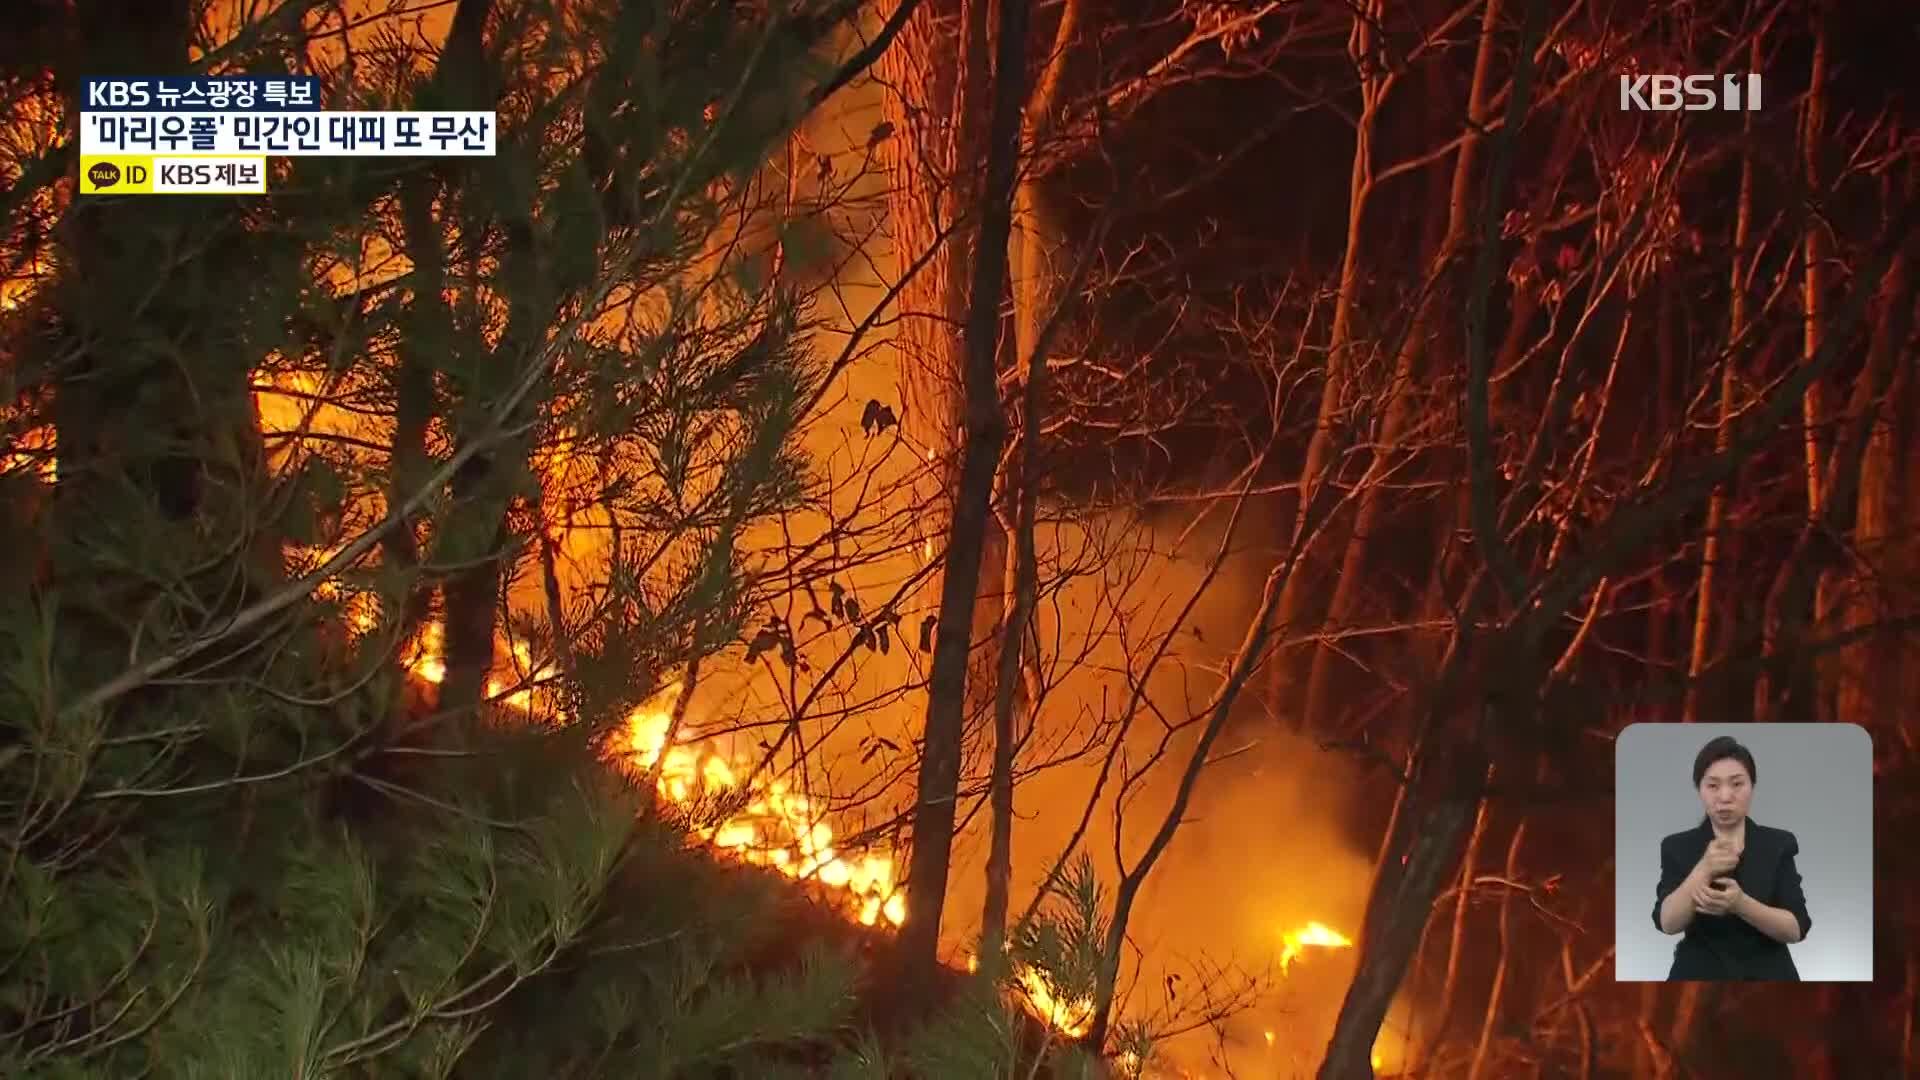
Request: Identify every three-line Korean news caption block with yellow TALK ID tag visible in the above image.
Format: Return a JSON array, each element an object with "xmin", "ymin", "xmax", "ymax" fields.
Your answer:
[{"xmin": 79, "ymin": 75, "xmax": 497, "ymax": 196}]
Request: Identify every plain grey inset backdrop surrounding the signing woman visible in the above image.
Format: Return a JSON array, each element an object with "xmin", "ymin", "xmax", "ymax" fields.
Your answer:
[{"xmin": 1613, "ymin": 724, "xmax": 1874, "ymax": 982}]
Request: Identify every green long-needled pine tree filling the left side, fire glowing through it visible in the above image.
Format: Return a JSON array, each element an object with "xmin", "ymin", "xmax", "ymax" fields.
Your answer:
[{"xmin": 0, "ymin": 0, "xmax": 1036, "ymax": 1078}]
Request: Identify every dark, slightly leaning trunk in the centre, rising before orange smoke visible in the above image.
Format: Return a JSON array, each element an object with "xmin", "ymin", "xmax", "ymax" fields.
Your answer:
[{"xmin": 899, "ymin": 0, "xmax": 1029, "ymax": 1001}]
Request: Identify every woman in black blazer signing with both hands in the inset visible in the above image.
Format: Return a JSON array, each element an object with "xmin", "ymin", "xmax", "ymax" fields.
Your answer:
[{"xmin": 1653, "ymin": 736, "xmax": 1812, "ymax": 982}]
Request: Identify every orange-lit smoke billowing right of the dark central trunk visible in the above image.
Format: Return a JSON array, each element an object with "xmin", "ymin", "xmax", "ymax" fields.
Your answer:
[{"xmin": 913, "ymin": 503, "xmax": 1394, "ymax": 1076}]
